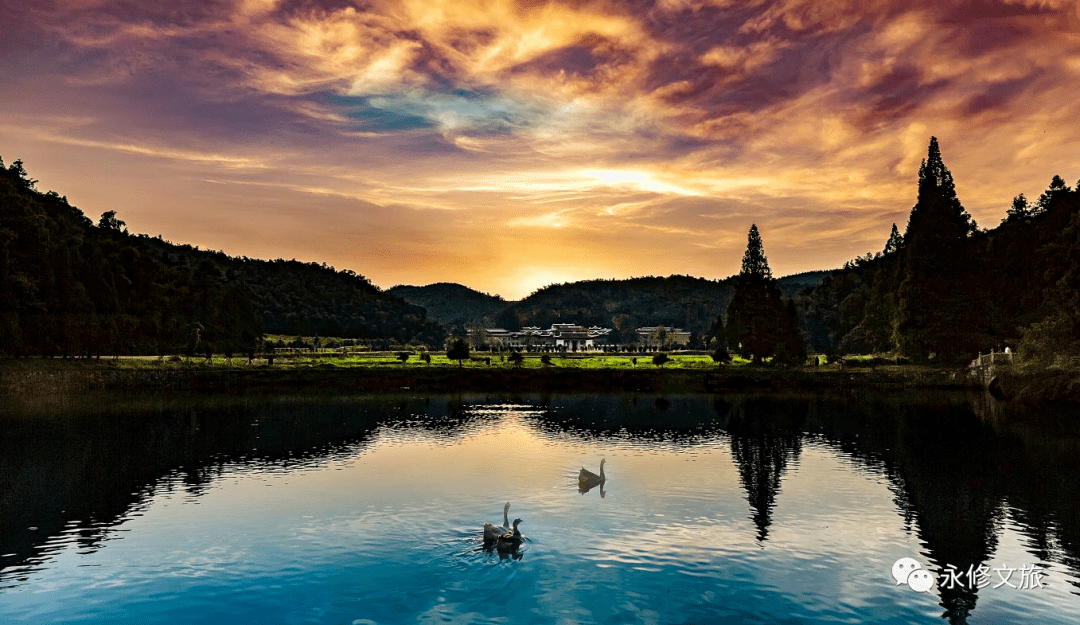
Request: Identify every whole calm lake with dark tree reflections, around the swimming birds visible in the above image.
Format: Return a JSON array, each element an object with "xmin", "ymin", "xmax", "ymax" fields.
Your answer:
[{"xmin": 0, "ymin": 394, "xmax": 1080, "ymax": 625}]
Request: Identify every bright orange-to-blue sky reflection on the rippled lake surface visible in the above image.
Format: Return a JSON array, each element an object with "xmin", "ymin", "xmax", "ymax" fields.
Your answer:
[{"xmin": 0, "ymin": 407, "xmax": 1077, "ymax": 623}]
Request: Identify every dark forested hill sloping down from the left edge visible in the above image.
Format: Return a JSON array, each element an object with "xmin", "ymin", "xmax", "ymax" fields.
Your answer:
[{"xmin": 0, "ymin": 156, "xmax": 443, "ymax": 356}]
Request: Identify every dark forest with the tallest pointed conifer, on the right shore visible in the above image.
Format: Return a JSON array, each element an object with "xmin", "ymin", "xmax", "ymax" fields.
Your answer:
[{"xmin": 798, "ymin": 138, "xmax": 1080, "ymax": 364}]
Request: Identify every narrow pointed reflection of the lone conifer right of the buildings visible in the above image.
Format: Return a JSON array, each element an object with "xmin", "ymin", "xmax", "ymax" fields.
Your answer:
[{"xmin": 728, "ymin": 399, "xmax": 806, "ymax": 542}]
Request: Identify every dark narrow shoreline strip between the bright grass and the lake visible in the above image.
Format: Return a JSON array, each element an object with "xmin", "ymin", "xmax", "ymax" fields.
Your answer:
[{"xmin": 0, "ymin": 359, "xmax": 1080, "ymax": 405}]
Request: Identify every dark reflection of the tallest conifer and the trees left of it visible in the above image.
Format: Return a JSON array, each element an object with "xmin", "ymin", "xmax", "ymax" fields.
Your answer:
[{"xmin": 794, "ymin": 396, "xmax": 1002, "ymax": 624}]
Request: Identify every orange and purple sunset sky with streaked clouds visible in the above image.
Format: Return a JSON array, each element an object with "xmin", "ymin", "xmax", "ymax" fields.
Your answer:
[{"xmin": 0, "ymin": 0, "xmax": 1080, "ymax": 299}]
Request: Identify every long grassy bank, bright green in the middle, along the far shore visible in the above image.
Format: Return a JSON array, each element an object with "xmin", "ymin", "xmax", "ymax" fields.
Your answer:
[{"xmin": 0, "ymin": 354, "xmax": 972, "ymax": 394}]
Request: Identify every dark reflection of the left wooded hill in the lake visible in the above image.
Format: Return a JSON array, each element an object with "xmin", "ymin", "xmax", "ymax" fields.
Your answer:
[{"xmin": 0, "ymin": 392, "xmax": 394, "ymax": 582}]
